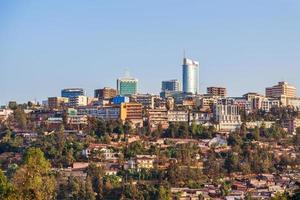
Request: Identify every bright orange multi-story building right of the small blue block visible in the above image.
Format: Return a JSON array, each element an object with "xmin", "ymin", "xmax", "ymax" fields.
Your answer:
[{"xmin": 120, "ymin": 102, "xmax": 143, "ymax": 126}]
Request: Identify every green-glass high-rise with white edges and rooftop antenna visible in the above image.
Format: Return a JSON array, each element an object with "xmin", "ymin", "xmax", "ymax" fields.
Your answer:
[{"xmin": 117, "ymin": 77, "xmax": 138, "ymax": 96}]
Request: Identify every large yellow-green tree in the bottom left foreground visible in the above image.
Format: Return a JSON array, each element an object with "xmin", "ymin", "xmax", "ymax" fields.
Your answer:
[{"xmin": 13, "ymin": 148, "xmax": 56, "ymax": 200}]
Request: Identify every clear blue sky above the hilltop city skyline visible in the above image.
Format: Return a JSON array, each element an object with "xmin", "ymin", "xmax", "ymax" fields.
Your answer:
[{"xmin": 0, "ymin": 0, "xmax": 300, "ymax": 104}]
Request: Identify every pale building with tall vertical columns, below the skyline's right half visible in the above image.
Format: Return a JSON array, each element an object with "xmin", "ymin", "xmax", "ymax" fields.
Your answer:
[{"xmin": 214, "ymin": 104, "xmax": 242, "ymax": 131}]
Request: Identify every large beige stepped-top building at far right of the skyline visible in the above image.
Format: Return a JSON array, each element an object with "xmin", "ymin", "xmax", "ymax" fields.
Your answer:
[{"xmin": 266, "ymin": 82, "xmax": 296, "ymax": 98}]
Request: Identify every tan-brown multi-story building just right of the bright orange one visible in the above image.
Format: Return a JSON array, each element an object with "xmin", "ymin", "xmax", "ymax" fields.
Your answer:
[{"xmin": 147, "ymin": 109, "xmax": 169, "ymax": 131}]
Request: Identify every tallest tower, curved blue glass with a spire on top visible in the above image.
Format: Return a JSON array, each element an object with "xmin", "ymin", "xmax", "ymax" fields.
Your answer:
[{"xmin": 182, "ymin": 58, "xmax": 199, "ymax": 94}]
